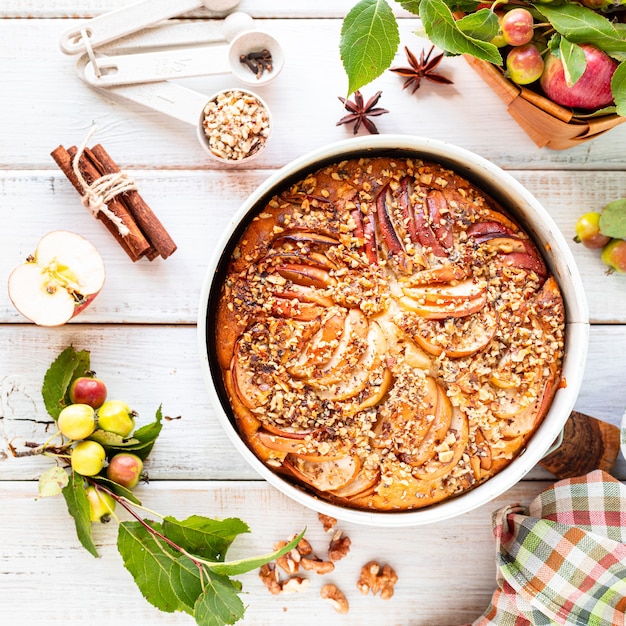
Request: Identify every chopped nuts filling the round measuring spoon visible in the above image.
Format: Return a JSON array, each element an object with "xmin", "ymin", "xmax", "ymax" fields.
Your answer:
[{"xmin": 198, "ymin": 89, "xmax": 271, "ymax": 163}]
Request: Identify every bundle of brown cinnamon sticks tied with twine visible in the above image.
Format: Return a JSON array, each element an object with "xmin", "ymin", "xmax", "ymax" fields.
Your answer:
[{"xmin": 51, "ymin": 144, "xmax": 176, "ymax": 262}]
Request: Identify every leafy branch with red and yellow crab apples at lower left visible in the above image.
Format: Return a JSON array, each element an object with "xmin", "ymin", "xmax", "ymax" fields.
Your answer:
[{"xmin": 12, "ymin": 346, "xmax": 304, "ymax": 626}]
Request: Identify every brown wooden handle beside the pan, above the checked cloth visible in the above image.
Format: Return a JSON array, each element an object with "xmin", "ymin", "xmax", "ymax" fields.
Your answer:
[{"xmin": 539, "ymin": 411, "xmax": 620, "ymax": 478}]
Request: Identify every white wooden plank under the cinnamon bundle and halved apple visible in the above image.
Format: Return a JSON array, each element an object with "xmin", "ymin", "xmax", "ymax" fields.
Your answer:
[{"xmin": 0, "ymin": 169, "xmax": 626, "ymax": 324}]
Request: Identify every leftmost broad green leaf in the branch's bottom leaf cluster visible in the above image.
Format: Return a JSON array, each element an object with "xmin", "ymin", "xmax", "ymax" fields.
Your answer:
[{"xmin": 117, "ymin": 520, "xmax": 196, "ymax": 613}]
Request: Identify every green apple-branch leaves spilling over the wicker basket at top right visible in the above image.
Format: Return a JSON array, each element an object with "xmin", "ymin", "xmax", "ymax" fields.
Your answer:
[{"xmin": 339, "ymin": 0, "xmax": 626, "ymax": 116}]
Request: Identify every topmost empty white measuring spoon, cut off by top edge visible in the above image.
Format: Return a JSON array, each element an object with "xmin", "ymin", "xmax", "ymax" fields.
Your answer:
[{"xmin": 60, "ymin": 0, "xmax": 239, "ymax": 54}]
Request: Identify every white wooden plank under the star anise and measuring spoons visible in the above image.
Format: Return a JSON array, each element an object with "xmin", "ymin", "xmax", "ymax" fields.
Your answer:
[{"xmin": 0, "ymin": 19, "xmax": 626, "ymax": 170}]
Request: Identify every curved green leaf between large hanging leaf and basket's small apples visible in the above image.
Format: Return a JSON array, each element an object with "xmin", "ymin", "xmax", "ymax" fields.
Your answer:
[{"xmin": 420, "ymin": 0, "xmax": 502, "ymax": 65}]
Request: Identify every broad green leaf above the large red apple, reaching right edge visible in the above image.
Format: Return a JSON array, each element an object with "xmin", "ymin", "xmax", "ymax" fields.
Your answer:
[{"xmin": 535, "ymin": 3, "xmax": 626, "ymax": 57}]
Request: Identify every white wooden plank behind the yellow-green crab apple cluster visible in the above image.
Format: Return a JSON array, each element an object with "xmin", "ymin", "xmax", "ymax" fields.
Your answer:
[{"xmin": 0, "ymin": 324, "xmax": 626, "ymax": 481}]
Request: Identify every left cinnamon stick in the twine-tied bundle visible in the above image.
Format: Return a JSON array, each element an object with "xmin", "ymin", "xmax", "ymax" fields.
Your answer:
[{"xmin": 51, "ymin": 146, "xmax": 150, "ymax": 262}]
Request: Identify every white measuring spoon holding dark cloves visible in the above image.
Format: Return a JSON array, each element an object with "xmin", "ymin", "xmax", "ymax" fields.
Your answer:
[{"xmin": 83, "ymin": 30, "xmax": 284, "ymax": 87}]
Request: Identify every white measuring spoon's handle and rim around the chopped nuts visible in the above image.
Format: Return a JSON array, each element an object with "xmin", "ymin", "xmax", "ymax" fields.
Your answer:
[{"xmin": 76, "ymin": 54, "xmax": 271, "ymax": 164}]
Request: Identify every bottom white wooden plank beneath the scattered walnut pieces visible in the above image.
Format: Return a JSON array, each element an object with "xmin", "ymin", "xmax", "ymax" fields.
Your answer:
[{"xmin": 0, "ymin": 481, "xmax": 549, "ymax": 626}]
